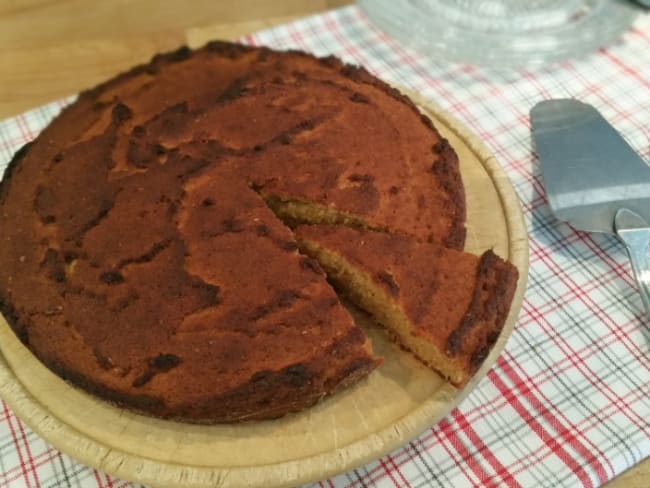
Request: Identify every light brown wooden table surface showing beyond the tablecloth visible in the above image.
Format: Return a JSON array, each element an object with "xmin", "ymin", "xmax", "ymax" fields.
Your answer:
[{"xmin": 0, "ymin": 0, "xmax": 650, "ymax": 488}]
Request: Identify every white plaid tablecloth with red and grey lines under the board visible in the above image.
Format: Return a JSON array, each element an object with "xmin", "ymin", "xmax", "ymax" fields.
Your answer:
[{"xmin": 0, "ymin": 6, "xmax": 650, "ymax": 487}]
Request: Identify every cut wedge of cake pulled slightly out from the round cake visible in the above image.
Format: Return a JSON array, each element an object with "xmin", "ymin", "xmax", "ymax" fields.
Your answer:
[{"xmin": 295, "ymin": 225, "xmax": 518, "ymax": 386}]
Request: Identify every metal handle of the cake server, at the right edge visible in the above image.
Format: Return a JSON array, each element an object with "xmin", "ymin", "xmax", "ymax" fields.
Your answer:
[{"xmin": 614, "ymin": 208, "xmax": 650, "ymax": 320}]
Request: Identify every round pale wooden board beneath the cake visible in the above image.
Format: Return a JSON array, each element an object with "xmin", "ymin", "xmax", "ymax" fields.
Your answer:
[{"xmin": 0, "ymin": 96, "xmax": 528, "ymax": 487}]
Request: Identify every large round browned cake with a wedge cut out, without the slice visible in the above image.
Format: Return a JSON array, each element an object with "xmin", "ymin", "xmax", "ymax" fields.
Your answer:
[{"xmin": 0, "ymin": 42, "xmax": 466, "ymax": 422}]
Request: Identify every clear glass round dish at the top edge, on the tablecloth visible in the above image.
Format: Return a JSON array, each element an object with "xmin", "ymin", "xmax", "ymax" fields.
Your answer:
[{"xmin": 357, "ymin": 0, "xmax": 639, "ymax": 68}]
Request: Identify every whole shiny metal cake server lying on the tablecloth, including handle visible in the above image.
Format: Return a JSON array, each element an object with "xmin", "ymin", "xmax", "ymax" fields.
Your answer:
[{"xmin": 530, "ymin": 99, "xmax": 650, "ymax": 318}]
